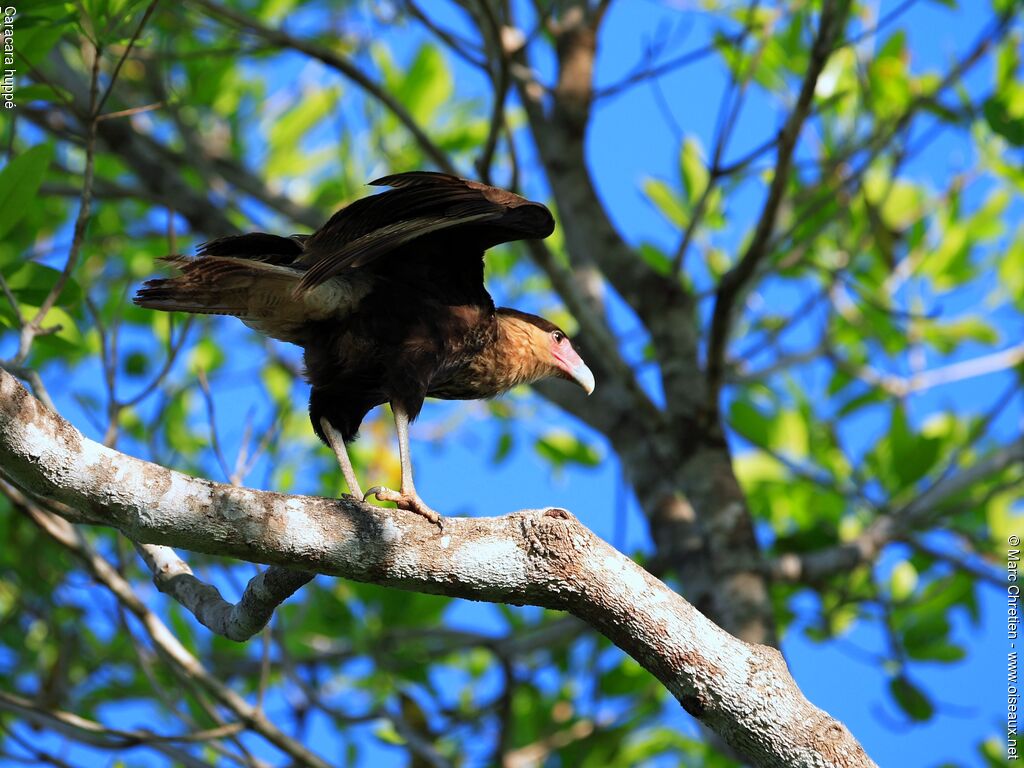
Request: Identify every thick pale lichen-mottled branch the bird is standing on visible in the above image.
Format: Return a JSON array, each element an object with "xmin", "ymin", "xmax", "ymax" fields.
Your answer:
[{"xmin": 0, "ymin": 371, "xmax": 873, "ymax": 766}]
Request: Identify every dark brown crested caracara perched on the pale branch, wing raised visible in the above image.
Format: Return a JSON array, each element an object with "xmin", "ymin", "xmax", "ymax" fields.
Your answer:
[{"xmin": 134, "ymin": 171, "xmax": 595, "ymax": 524}]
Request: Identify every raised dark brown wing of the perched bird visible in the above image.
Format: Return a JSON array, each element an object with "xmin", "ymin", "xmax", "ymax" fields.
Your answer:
[{"xmin": 299, "ymin": 171, "xmax": 554, "ymax": 290}]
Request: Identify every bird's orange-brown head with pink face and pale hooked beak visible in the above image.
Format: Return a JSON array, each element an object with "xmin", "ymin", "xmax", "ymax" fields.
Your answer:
[{"xmin": 499, "ymin": 307, "xmax": 594, "ymax": 394}]
